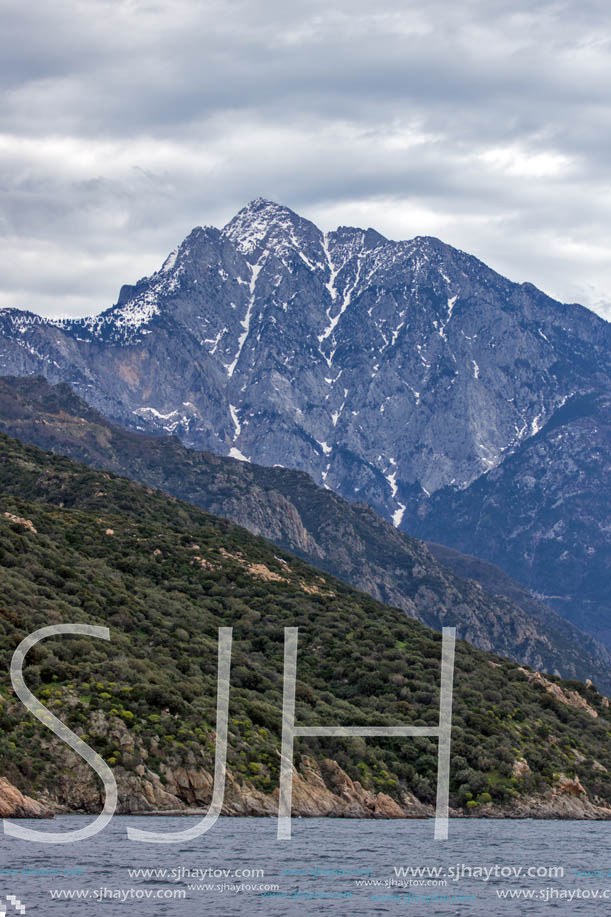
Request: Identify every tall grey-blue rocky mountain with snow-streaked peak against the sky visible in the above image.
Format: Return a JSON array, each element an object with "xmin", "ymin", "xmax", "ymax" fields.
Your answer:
[{"xmin": 0, "ymin": 199, "xmax": 611, "ymax": 639}]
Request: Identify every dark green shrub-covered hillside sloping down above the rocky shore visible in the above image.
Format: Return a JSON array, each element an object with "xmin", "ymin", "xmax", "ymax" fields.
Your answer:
[{"xmin": 0, "ymin": 435, "xmax": 611, "ymax": 806}]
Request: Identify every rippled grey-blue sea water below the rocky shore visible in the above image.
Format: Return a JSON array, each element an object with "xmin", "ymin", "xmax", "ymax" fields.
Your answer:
[{"xmin": 0, "ymin": 816, "xmax": 611, "ymax": 917}]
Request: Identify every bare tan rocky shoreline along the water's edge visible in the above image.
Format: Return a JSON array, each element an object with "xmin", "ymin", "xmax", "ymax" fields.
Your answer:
[{"xmin": 0, "ymin": 758, "xmax": 611, "ymax": 820}]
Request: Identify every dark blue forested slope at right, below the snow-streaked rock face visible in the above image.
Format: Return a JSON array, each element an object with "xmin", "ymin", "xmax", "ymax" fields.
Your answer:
[{"xmin": 413, "ymin": 393, "xmax": 611, "ymax": 644}]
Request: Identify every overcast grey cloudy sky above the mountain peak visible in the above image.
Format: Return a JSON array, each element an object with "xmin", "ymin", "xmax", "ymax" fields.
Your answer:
[{"xmin": 0, "ymin": 0, "xmax": 611, "ymax": 318}]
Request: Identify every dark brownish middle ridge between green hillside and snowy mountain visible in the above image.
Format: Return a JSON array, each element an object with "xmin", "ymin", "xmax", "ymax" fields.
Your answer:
[{"xmin": 0, "ymin": 377, "xmax": 611, "ymax": 691}]
